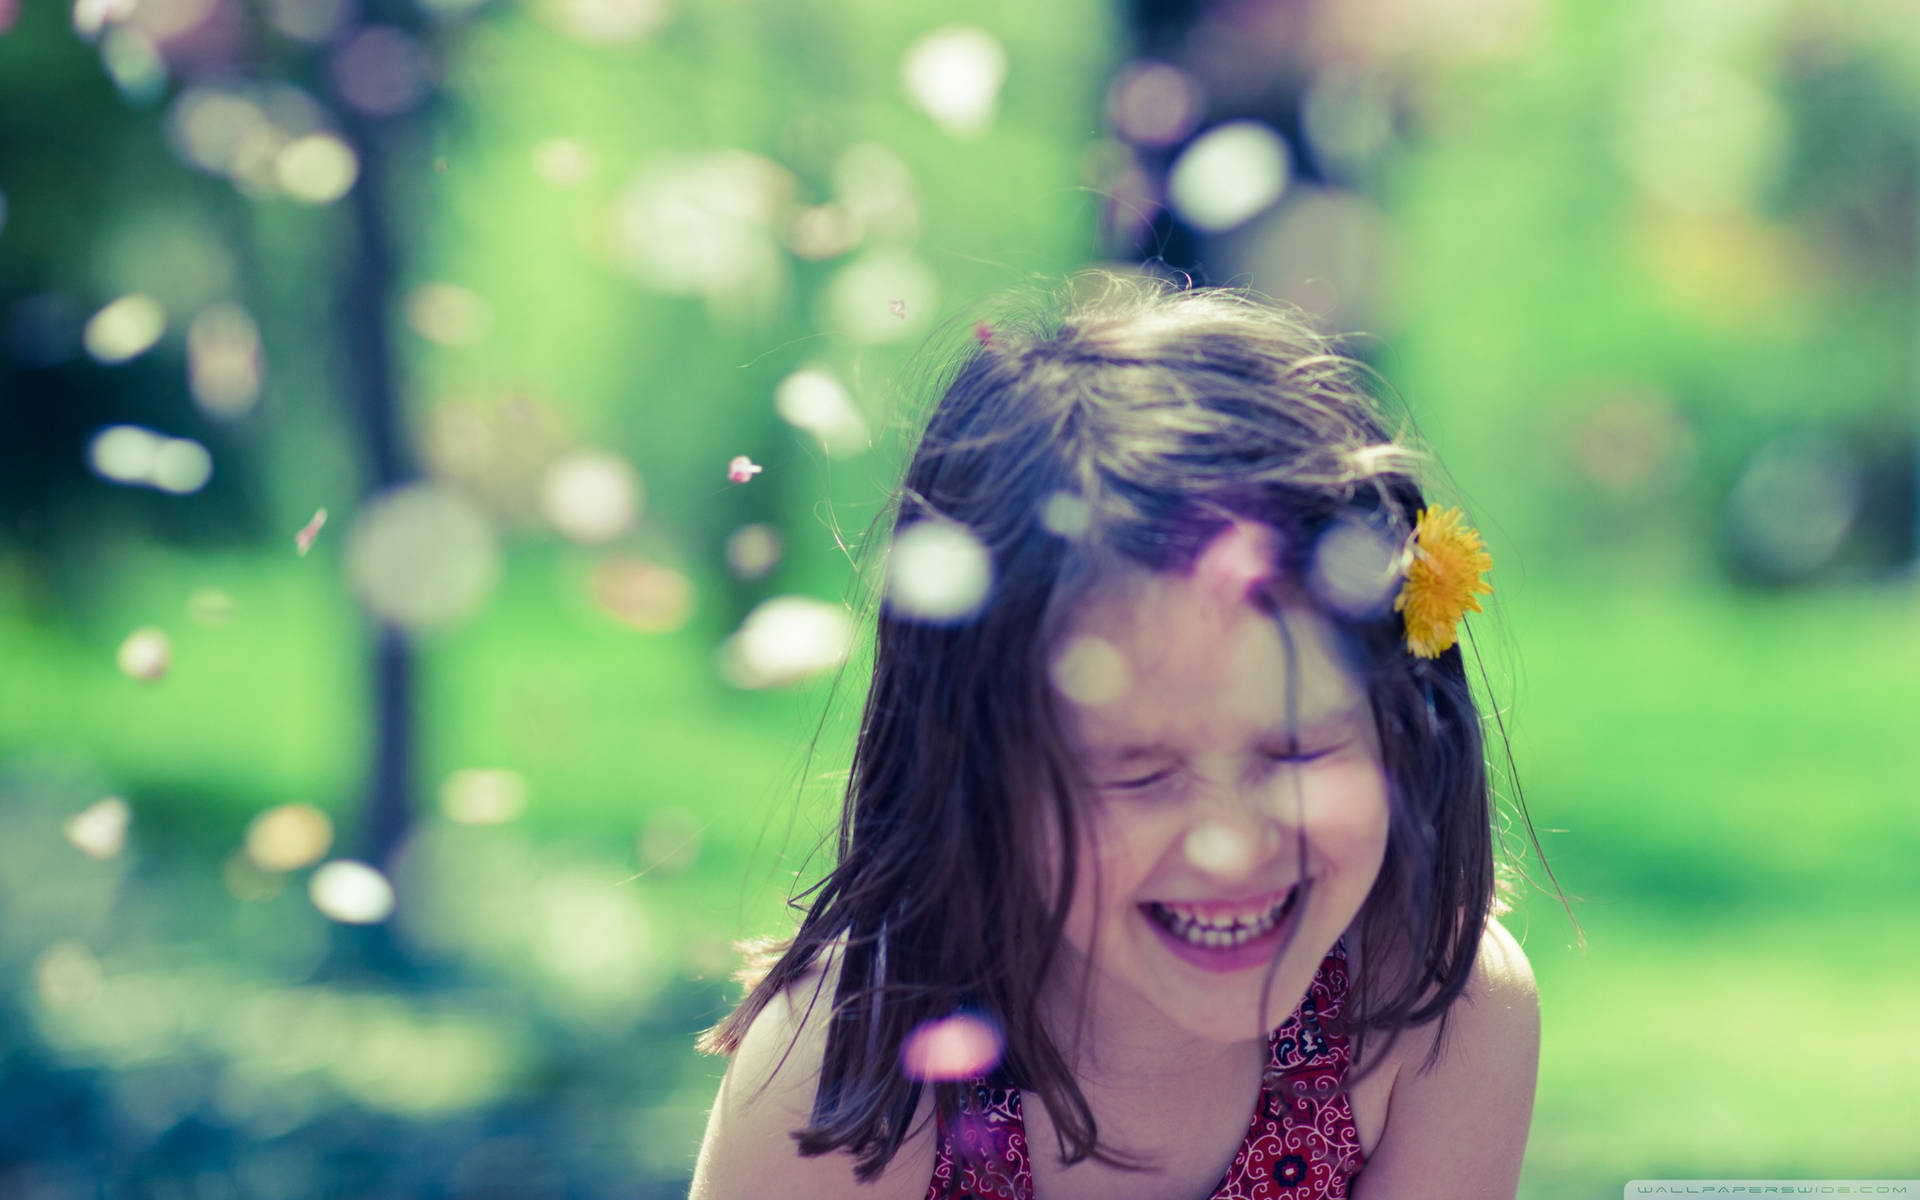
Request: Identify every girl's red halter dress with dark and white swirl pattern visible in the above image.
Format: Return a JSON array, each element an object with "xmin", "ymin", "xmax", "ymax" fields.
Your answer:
[{"xmin": 927, "ymin": 941, "xmax": 1361, "ymax": 1200}]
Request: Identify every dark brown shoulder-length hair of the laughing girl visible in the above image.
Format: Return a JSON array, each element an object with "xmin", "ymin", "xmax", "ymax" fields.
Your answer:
[{"xmin": 703, "ymin": 276, "xmax": 1551, "ymax": 1179}]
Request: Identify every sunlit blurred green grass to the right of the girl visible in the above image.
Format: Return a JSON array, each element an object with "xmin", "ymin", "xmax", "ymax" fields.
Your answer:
[{"xmin": 1509, "ymin": 588, "xmax": 1920, "ymax": 1200}]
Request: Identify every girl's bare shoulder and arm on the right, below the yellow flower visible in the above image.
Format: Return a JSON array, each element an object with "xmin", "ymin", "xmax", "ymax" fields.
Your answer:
[{"xmin": 1354, "ymin": 918, "xmax": 1540, "ymax": 1200}]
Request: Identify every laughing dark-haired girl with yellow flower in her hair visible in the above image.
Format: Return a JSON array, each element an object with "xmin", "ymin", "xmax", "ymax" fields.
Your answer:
[{"xmin": 693, "ymin": 282, "xmax": 1540, "ymax": 1200}]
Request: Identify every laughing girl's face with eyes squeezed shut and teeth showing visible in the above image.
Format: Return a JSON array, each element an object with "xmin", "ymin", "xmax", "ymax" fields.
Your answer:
[{"xmin": 1054, "ymin": 526, "xmax": 1388, "ymax": 1041}]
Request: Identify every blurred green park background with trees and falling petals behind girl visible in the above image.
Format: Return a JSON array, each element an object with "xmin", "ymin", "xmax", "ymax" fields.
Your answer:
[{"xmin": 0, "ymin": 0, "xmax": 1920, "ymax": 1198}]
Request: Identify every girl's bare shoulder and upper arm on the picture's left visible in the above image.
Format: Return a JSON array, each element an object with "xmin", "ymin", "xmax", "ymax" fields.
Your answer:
[{"xmin": 691, "ymin": 948, "xmax": 933, "ymax": 1200}]
